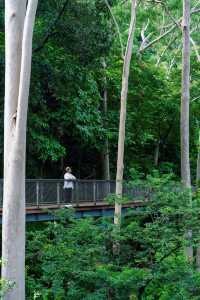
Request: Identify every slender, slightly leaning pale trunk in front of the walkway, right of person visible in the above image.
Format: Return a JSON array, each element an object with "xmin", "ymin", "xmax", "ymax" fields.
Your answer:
[{"xmin": 114, "ymin": 0, "xmax": 137, "ymax": 225}]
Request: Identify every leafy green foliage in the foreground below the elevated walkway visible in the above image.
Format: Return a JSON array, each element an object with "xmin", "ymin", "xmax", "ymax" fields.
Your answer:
[{"xmin": 27, "ymin": 174, "xmax": 200, "ymax": 300}]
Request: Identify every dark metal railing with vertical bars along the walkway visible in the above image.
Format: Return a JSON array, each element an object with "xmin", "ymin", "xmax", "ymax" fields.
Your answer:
[{"xmin": 0, "ymin": 179, "xmax": 148, "ymax": 207}]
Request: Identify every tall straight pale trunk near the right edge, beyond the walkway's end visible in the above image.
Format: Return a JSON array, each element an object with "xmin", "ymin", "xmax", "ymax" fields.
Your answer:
[{"xmin": 181, "ymin": 0, "xmax": 193, "ymax": 262}]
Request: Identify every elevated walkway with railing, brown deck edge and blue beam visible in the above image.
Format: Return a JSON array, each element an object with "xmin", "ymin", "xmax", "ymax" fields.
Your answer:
[{"xmin": 0, "ymin": 179, "xmax": 149, "ymax": 222}]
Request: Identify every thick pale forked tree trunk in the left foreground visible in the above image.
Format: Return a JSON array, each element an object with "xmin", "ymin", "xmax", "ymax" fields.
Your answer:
[{"xmin": 2, "ymin": 0, "xmax": 37, "ymax": 300}]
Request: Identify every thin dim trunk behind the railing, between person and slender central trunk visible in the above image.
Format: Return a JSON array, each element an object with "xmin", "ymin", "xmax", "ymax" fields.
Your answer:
[{"xmin": 102, "ymin": 59, "xmax": 110, "ymax": 180}]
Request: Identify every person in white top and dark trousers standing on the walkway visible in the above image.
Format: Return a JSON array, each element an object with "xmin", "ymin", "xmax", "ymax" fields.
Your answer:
[{"xmin": 64, "ymin": 167, "xmax": 76, "ymax": 206}]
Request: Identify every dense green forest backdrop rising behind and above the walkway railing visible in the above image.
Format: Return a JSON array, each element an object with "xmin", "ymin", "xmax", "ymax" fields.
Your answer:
[{"xmin": 0, "ymin": 0, "xmax": 200, "ymax": 179}]
